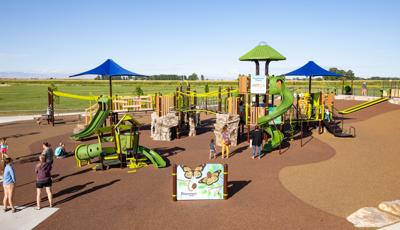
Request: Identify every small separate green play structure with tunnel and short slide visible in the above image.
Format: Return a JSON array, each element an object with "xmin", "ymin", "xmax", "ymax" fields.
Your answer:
[{"xmin": 75, "ymin": 114, "xmax": 166, "ymax": 169}]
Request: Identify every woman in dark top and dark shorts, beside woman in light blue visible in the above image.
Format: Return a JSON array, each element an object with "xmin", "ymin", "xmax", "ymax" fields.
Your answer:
[{"xmin": 35, "ymin": 155, "xmax": 53, "ymax": 210}]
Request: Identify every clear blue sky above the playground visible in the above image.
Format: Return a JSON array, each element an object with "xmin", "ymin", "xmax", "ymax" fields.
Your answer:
[{"xmin": 0, "ymin": 0, "xmax": 400, "ymax": 79}]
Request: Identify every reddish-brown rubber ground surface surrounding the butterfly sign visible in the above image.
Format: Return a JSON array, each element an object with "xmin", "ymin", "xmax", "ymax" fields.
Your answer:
[{"xmin": 1, "ymin": 115, "xmax": 351, "ymax": 229}]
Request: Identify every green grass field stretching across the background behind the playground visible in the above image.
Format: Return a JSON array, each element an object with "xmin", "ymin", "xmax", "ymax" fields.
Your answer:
[{"xmin": 0, "ymin": 79, "xmax": 400, "ymax": 116}]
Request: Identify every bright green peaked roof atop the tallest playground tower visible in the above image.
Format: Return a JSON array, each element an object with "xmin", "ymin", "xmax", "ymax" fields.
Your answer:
[{"xmin": 239, "ymin": 44, "xmax": 286, "ymax": 61}]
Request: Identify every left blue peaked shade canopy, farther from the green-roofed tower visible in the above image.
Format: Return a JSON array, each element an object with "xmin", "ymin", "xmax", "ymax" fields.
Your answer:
[{"xmin": 70, "ymin": 59, "xmax": 144, "ymax": 77}]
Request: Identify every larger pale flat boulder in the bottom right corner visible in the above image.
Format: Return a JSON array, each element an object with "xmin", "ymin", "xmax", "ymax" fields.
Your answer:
[{"xmin": 347, "ymin": 207, "xmax": 400, "ymax": 228}]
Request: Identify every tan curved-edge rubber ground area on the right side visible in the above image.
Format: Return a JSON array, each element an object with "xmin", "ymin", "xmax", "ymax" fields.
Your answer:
[{"xmin": 280, "ymin": 106, "xmax": 400, "ymax": 217}]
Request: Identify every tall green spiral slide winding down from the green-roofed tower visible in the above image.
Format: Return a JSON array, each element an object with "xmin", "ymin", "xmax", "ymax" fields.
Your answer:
[{"xmin": 258, "ymin": 76, "xmax": 293, "ymax": 152}]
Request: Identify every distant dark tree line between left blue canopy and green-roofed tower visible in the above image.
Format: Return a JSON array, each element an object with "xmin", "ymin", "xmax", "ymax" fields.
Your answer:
[{"xmin": 95, "ymin": 73, "xmax": 207, "ymax": 81}]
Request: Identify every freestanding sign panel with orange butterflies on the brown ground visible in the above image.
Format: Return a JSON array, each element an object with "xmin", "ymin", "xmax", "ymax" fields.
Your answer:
[{"xmin": 172, "ymin": 164, "xmax": 228, "ymax": 200}]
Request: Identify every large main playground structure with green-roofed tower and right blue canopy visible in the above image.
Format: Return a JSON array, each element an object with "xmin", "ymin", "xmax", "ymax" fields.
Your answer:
[{"xmin": 43, "ymin": 44, "xmax": 398, "ymax": 156}]
